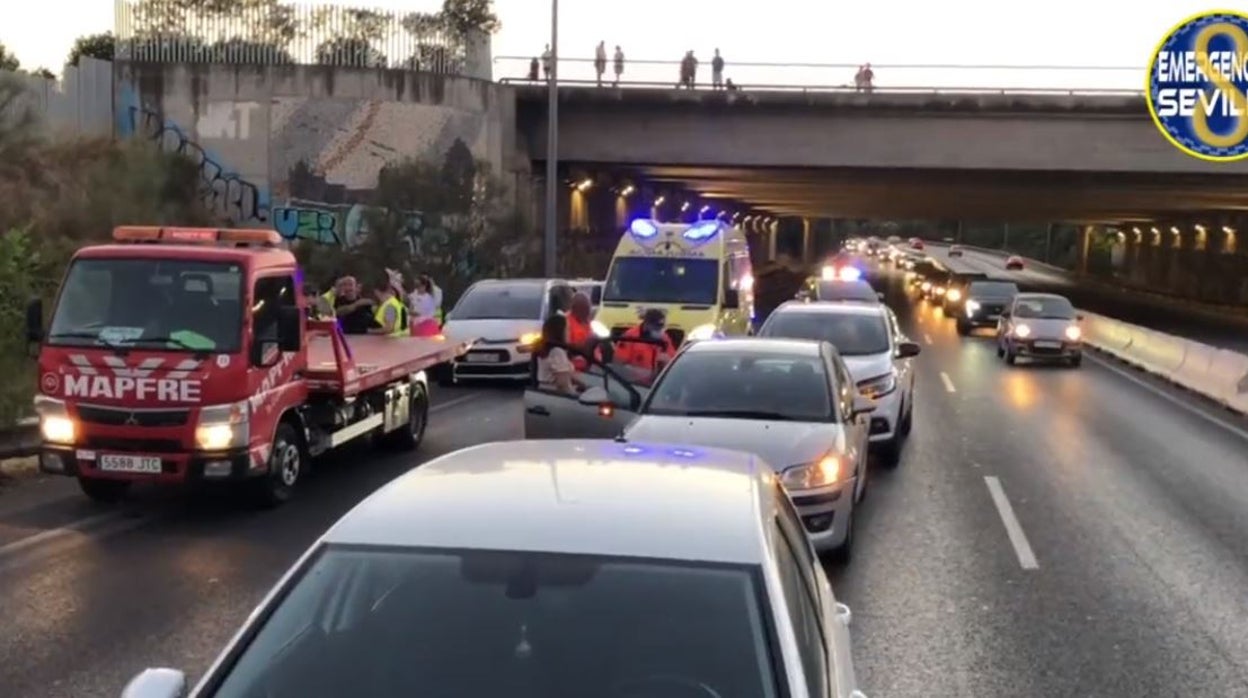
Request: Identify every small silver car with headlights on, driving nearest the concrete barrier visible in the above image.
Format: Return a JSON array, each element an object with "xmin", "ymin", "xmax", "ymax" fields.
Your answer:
[{"xmin": 997, "ymin": 293, "xmax": 1083, "ymax": 367}]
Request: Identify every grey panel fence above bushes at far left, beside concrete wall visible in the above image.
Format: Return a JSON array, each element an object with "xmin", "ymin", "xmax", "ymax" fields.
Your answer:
[{"xmin": 1, "ymin": 57, "xmax": 112, "ymax": 137}]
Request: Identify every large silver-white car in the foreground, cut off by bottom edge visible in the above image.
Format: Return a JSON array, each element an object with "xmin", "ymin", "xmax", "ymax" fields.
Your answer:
[{"xmin": 124, "ymin": 441, "xmax": 861, "ymax": 698}]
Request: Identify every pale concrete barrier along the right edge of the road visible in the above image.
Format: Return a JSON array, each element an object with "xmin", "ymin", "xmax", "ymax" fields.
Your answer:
[{"xmin": 1080, "ymin": 311, "xmax": 1248, "ymax": 415}]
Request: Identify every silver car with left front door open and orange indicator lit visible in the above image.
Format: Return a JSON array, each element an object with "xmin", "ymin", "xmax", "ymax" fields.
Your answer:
[{"xmin": 525, "ymin": 338, "xmax": 875, "ymax": 561}]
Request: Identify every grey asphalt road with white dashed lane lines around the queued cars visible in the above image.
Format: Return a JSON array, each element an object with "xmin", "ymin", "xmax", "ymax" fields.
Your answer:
[{"xmin": 0, "ymin": 275, "xmax": 1248, "ymax": 698}]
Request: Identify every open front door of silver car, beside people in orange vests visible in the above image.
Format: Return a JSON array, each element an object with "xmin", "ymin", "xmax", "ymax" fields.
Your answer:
[{"xmin": 524, "ymin": 340, "xmax": 658, "ymax": 438}]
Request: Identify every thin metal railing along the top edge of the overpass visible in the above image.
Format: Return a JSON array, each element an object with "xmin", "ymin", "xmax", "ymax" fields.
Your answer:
[{"xmin": 493, "ymin": 56, "xmax": 1144, "ymax": 95}]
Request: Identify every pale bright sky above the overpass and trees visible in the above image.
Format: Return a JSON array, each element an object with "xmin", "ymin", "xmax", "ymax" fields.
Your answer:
[{"xmin": 0, "ymin": 0, "xmax": 1216, "ymax": 89}]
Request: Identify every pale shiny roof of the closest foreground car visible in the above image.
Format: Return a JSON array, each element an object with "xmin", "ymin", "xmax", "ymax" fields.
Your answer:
[{"xmin": 323, "ymin": 440, "xmax": 776, "ymax": 564}]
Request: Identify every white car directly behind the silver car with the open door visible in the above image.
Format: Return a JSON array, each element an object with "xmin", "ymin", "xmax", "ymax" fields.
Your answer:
[{"xmin": 759, "ymin": 301, "xmax": 920, "ymax": 465}]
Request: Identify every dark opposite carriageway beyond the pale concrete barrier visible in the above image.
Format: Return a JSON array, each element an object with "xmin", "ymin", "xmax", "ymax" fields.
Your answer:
[{"xmin": 926, "ymin": 245, "xmax": 1248, "ymax": 353}]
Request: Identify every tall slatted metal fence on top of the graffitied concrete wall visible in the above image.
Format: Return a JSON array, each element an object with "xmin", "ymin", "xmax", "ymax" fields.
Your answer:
[{"xmin": 115, "ymin": 0, "xmax": 493, "ymax": 80}]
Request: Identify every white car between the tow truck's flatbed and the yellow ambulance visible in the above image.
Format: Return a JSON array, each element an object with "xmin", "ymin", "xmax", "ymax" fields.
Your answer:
[{"xmin": 442, "ymin": 278, "xmax": 570, "ymax": 381}]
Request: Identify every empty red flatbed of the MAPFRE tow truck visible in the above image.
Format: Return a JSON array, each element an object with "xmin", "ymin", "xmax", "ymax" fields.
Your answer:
[{"xmin": 306, "ymin": 321, "xmax": 472, "ymax": 397}]
